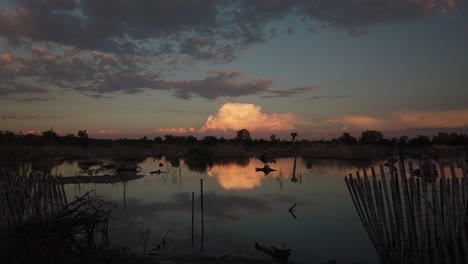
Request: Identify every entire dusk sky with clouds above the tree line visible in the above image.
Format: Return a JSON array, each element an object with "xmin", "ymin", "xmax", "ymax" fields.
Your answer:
[{"xmin": 0, "ymin": 0, "xmax": 468, "ymax": 139}]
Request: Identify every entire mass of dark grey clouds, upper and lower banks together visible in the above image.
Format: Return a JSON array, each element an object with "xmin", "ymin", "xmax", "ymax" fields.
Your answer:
[{"xmin": 0, "ymin": 0, "xmax": 460, "ymax": 99}]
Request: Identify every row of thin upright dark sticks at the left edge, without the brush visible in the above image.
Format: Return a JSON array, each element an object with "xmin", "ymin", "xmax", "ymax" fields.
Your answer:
[{"xmin": 0, "ymin": 167, "xmax": 68, "ymax": 230}]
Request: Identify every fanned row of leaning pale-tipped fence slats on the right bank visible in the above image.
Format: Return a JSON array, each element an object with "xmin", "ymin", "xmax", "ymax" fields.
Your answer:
[{"xmin": 345, "ymin": 162, "xmax": 468, "ymax": 264}]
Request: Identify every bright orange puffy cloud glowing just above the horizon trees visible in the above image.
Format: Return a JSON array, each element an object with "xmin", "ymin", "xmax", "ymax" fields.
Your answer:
[{"xmin": 201, "ymin": 103, "xmax": 300, "ymax": 131}]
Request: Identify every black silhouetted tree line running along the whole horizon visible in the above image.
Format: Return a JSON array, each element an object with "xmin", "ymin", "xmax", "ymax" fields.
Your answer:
[{"xmin": 0, "ymin": 129, "xmax": 468, "ymax": 145}]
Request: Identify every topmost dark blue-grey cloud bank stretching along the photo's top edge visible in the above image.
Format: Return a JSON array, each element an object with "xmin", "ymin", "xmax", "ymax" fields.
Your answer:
[{"xmin": 0, "ymin": 0, "xmax": 459, "ymax": 61}]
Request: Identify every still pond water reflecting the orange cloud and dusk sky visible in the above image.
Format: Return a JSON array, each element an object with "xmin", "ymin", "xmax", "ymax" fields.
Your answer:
[{"xmin": 55, "ymin": 158, "xmax": 379, "ymax": 263}]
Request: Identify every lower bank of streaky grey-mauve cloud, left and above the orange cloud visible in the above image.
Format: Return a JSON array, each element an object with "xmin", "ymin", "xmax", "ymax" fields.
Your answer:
[{"xmin": 0, "ymin": 47, "xmax": 313, "ymax": 100}]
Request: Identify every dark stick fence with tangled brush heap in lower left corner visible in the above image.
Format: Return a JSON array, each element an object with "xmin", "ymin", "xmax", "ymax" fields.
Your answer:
[{"xmin": 0, "ymin": 165, "xmax": 112, "ymax": 263}]
